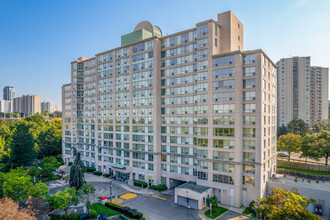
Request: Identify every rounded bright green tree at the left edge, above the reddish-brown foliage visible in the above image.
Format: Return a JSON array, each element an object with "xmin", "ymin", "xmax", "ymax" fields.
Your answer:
[{"xmin": 2, "ymin": 167, "xmax": 33, "ymax": 201}]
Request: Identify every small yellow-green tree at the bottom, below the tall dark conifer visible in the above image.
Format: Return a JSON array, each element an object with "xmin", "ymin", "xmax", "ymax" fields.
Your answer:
[{"xmin": 49, "ymin": 187, "xmax": 79, "ymax": 216}]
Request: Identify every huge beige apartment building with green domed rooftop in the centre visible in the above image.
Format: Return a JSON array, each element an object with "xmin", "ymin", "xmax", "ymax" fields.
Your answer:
[{"xmin": 62, "ymin": 11, "xmax": 277, "ymax": 208}]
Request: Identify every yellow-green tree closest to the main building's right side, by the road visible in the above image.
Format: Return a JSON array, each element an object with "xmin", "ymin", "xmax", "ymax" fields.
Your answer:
[{"xmin": 277, "ymin": 133, "xmax": 301, "ymax": 161}]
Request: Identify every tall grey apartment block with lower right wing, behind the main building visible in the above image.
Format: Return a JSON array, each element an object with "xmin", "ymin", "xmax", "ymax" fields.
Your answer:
[{"xmin": 277, "ymin": 57, "xmax": 328, "ymax": 126}]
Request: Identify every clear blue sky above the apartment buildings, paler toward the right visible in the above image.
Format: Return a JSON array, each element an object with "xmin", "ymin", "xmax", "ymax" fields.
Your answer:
[{"xmin": 0, "ymin": 0, "xmax": 330, "ymax": 107}]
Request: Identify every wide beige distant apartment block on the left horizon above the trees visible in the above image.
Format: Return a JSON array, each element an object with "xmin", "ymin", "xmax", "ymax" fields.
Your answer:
[{"xmin": 13, "ymin": 95, "xmax": 41, "ymax": 116}]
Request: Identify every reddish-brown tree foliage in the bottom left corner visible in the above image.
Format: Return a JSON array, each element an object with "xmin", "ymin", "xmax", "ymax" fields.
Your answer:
[{"xmin": 0, "ymin": 198, "xmax": 36, "ymax": 220}]
